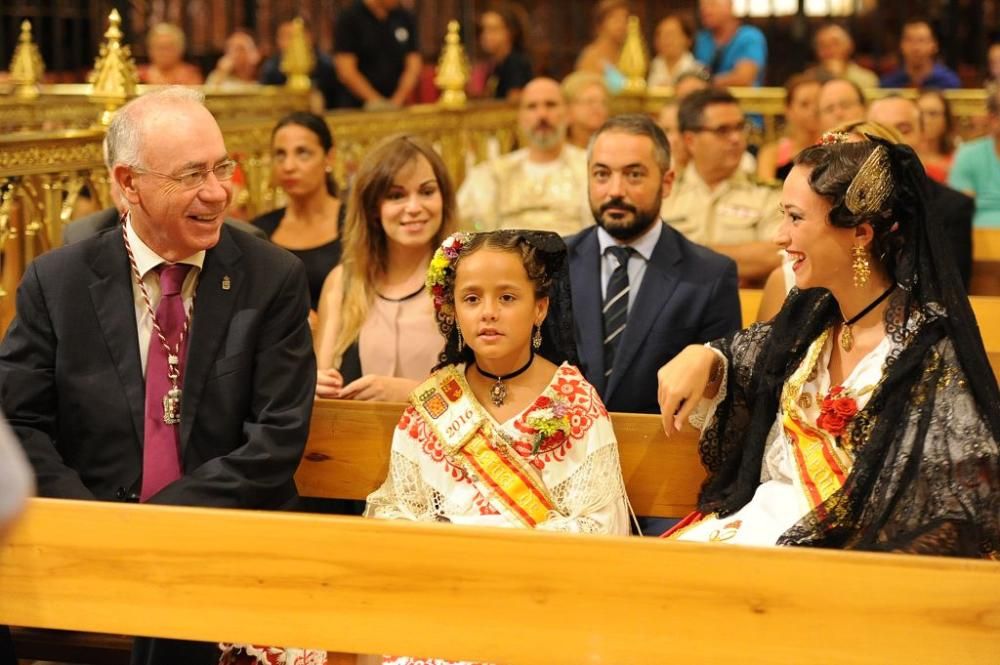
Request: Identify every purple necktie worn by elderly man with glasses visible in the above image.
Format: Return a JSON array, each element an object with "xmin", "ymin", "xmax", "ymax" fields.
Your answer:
[{"xmin": 139, "ymin": 263, "xmax": 191, "ymax": 501}]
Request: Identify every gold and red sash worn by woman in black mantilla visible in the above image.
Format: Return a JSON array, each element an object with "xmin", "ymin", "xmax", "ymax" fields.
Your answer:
[{"xmin": 781, "ymin": 330, "xmax": 853, "ymax": 510}]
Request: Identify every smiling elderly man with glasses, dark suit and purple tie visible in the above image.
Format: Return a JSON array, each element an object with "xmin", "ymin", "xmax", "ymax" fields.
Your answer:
[{"xmin": 0, "ymin": 88, "xmax": 316, "ymax": 665}]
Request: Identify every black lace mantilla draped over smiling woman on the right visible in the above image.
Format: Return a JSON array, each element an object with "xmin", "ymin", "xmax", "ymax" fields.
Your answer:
[{"xmin": 699, "ymin": 140, "xmax": 1000, "ymax": 558}]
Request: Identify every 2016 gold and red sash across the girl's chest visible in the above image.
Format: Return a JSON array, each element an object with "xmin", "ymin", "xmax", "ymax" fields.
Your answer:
[{"xmin": 410, "ymin": 365, "xmax": 555, "ymax": 527}]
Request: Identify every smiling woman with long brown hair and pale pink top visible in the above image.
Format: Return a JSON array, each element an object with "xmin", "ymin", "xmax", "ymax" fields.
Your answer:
[{"xmin": 315, "ymin": 136, "xmax": 457, "ymax": 401}]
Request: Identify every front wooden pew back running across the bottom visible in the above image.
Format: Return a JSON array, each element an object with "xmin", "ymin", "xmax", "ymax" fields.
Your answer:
[{"xmin": 0, "ymin": 499, "xmax": 1000, "ymax": 665}]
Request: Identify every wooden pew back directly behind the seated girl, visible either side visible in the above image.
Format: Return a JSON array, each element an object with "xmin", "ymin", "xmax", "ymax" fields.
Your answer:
[{"xmin": 295, "ymin": 400, "xmax": 705, "ymax": 517}]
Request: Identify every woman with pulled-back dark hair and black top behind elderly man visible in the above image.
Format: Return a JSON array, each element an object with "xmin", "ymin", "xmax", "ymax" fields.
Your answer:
[{"xmin": 252, "ymin": 111, "xmax": 344, "ymax": 318}]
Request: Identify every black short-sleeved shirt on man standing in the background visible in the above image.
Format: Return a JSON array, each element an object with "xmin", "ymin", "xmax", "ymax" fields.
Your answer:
[{"xmin": 334, "ymin": 0, "xmax": 417, "ymax": 107}]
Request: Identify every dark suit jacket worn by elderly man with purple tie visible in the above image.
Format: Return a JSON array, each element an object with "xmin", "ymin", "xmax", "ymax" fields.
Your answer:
[{"xmin": 0, "ymin": 226, "xmax": 316, "ymax": 508}]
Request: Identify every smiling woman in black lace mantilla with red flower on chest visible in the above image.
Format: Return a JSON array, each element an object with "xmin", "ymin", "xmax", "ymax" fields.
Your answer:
[{"xmin": 659, "ymin": 135, "xmax": 1000, "ymax": 558}]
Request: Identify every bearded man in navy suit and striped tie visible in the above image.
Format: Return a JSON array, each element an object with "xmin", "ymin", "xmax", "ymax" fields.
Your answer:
[{"xmin": 567, "ymin": 115, "xmax": 740, "ymax": 413}]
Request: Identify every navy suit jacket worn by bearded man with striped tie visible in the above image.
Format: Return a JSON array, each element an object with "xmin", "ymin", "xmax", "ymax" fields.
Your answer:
[{"xmin": 566, "ymin": 224, "xmax": 741, "ymax": 413}]
